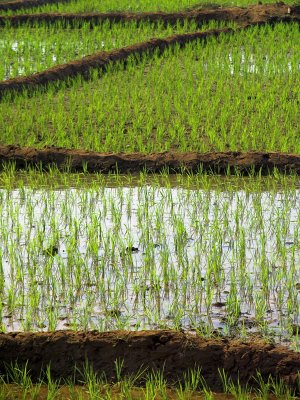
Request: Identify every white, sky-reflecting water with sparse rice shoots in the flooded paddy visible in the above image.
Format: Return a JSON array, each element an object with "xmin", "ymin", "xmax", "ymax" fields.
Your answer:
[{"xmin": 0, "ymin": 185, "xmax": 300, "ymax": 348}]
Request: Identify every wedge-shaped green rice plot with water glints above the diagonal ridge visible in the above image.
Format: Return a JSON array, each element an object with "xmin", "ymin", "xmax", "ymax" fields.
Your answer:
[{"xmin": 0, "ymin": 22, "xmax": 232, "ymax": 80}]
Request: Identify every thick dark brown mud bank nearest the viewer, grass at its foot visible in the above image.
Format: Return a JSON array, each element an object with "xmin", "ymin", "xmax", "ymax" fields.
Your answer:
[{"xmin": 0, "ymin": 330, "xmax": 300, "ymax": 391}]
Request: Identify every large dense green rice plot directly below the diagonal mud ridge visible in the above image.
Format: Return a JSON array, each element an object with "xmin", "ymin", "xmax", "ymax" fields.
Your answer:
[{"xmin": 0, "ymin": 24, "xmax": 300, "ymax": 153}]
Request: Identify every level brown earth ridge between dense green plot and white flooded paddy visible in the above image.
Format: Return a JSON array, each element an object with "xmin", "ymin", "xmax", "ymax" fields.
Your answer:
[{"xmin": 0, "ymin": 145, "xmax": 300, "ymax": 174}]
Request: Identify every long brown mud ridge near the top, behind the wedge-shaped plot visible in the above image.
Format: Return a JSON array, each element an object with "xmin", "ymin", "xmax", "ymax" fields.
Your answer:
[{"xmin": 0, "ymin": 0, "xmax": 300, "ymax": 27}]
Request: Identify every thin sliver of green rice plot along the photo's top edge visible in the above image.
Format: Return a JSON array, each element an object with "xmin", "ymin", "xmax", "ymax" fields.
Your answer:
[{"xmin": 2, "ymin": 0, "xmax": 292, "ymax": 14}]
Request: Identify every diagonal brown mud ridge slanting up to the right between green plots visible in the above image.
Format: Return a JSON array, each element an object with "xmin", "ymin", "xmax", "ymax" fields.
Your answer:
[{"xmin": 0, "ymin": 28, "xmax": 234, "ymax": 99}]
